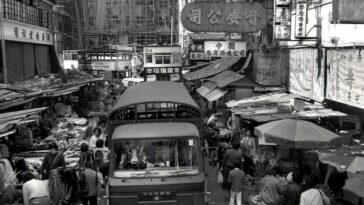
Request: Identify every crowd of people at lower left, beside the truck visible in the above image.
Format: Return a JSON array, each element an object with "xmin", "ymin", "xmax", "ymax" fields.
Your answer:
[{"xmin": 0, "ymin": 125, "xmax": 110, "ymax": 205}]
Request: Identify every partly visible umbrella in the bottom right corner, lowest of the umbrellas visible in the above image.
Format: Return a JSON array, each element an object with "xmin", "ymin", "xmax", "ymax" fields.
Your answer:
[{"xmin": 343, "ymin": 173, "xmax": 364, "ymax": 204}]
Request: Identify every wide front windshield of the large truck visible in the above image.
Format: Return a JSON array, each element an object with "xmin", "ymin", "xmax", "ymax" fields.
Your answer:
[{"xmin": 113, "ymin": 138, "xmax": 201, "ymax": 178}]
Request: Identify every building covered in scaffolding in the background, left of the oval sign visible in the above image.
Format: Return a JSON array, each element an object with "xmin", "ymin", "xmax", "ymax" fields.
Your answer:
[{"xmin": 80, "ymin": 0, "xmax": 178, "ymax": 48}]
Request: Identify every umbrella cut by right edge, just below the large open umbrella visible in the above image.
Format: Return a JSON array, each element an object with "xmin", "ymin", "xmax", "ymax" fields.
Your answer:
[{"xmin": 315, "ymin": 145, "xmax": 364, "ymax": 176}]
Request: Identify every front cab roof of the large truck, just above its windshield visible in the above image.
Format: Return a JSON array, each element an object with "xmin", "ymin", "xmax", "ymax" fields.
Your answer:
[{"xmin": 111, "ymin": 122, "xmax": 199, "ymax": 140}]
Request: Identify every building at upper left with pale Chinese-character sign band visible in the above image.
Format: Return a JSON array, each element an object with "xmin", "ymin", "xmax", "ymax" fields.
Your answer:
[{"xmin": 1, "ymin": 0, "xmax": 60, "ymax": 83}]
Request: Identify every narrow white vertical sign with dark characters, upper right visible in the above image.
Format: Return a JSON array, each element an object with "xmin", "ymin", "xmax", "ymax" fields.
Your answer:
[{"xmin": 295, "ymin": 2, "xmax": 307, "ymax": 38}]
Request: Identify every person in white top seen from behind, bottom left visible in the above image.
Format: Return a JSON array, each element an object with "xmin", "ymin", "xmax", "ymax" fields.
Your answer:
[{"xmin": 22, "ymin": 173, "xmax": 50, "ymax": 205}]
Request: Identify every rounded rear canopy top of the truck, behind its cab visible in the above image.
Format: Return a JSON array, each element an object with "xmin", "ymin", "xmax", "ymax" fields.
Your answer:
[{"xmin": 109, "ymin": 81, "xmax": 200, "ymax": 116}]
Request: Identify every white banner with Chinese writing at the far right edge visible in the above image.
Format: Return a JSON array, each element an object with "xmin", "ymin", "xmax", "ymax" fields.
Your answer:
[{"xmin": 326, "ymin": 50, "xmax": 364, "ymax": 108}]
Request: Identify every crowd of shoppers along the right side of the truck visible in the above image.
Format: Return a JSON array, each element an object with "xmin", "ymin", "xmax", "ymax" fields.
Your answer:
[{"xmin": 206, "ymin": 113, "xmax": 346, "ymax": 205}]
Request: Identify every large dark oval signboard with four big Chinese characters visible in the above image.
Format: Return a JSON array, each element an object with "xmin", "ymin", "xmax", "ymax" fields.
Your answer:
[{"xmin": 181, "ymin": 2, "xmax": 267, "ymax": 33}]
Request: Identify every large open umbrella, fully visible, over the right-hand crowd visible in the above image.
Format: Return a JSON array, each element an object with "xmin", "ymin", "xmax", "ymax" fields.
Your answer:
[{"xmin": 254, "ymin": 119, "xmax": 340, "ymax": 149}]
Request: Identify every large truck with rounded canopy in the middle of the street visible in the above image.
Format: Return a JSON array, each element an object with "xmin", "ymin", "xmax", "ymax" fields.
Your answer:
[{"xmin": 106, "ymin": 81, "xmax": 207, "ymax": 205}]
